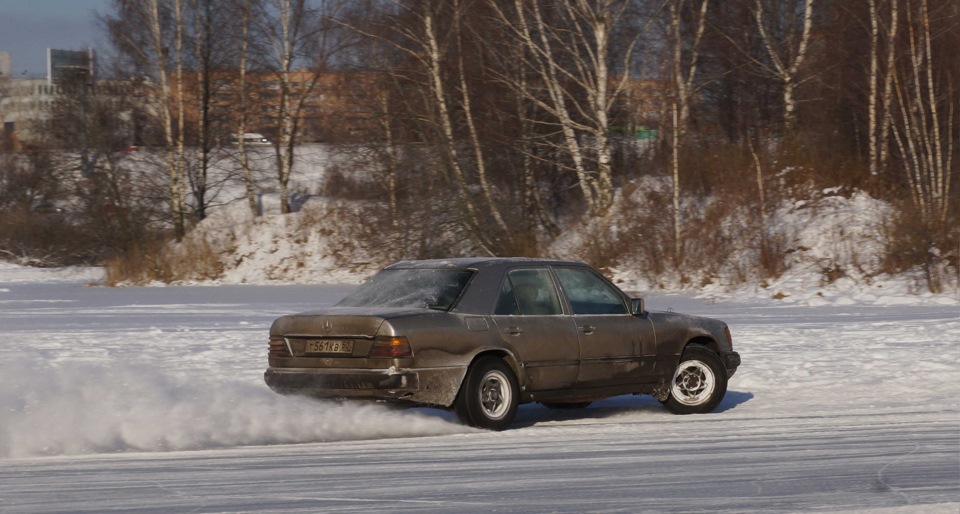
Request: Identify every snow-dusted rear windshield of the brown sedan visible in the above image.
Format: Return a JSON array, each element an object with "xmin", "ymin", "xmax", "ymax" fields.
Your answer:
[{"xmin": 337, "ymin": 269, "xmax": 472, "ymax": 311}]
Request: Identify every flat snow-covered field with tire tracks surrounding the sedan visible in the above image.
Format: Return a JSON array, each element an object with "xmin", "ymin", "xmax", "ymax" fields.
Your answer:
[{"xmin": 0, "ymin": 264, "xmax": 960, "ymax": 514}]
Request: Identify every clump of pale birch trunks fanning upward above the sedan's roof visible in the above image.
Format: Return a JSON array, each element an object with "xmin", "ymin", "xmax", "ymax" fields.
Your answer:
[{"xmin": 490, "ymin": 0, "xmax": 636, "ymax": 216}]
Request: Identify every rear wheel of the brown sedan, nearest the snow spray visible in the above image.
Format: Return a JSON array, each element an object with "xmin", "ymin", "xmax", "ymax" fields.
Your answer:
[{"xmin": 453, "ymin": 356, "xmax": 520, "ymax": 430}]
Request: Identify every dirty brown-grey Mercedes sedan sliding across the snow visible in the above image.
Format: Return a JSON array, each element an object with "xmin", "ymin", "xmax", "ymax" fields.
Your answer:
[{"xmin": 264, "ymin": 258, "xmax": 740, "ymax": 430}]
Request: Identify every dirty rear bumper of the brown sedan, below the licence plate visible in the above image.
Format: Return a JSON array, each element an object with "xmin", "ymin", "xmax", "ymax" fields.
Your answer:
[{"xmin": 263, "ymin": 367, "xmax": 466, "ymax": 407}]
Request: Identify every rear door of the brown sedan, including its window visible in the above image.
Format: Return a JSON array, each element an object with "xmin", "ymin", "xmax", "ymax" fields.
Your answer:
[{"xmin": 493, "ymin": 267, "xmax": 580, "ymax": 391}]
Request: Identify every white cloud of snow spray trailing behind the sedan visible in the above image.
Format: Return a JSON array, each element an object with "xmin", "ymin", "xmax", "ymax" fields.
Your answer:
[{"xmin": 0, "ymin": 356, "xmax": 471, "ymax": 458}]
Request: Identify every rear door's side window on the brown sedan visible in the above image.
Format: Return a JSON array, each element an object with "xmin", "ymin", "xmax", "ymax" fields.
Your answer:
[{"xmin": 494, "ymin": 269, "xmax": 563, "ymax": 316}]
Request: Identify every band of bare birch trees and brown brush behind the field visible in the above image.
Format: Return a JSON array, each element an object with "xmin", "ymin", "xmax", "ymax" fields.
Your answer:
[{"xmin": 0, "ymin": 0, "xmax": 960, "ymax": 290}]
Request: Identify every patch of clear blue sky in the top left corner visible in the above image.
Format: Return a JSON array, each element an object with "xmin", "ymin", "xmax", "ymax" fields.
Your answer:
[{"xmin": 0, "ymin": 0, "xmax": 110, "ymax": 77}]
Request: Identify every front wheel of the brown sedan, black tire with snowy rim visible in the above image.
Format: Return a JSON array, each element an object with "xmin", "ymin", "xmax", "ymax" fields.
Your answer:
[{"xmin": 663, "ymin": 346, "xmax": 727, "ymax": 414}]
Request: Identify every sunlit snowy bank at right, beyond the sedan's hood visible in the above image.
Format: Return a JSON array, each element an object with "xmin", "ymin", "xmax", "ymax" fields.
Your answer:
[{"xmin": 613, "ymin": 189, "xmax": 960, "ymax": 306}]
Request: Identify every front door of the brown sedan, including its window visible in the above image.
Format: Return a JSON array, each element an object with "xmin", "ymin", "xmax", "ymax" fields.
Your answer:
[{"xmin": 554, "ymin": 267, "xmax": 656, "ymax": 388}]
